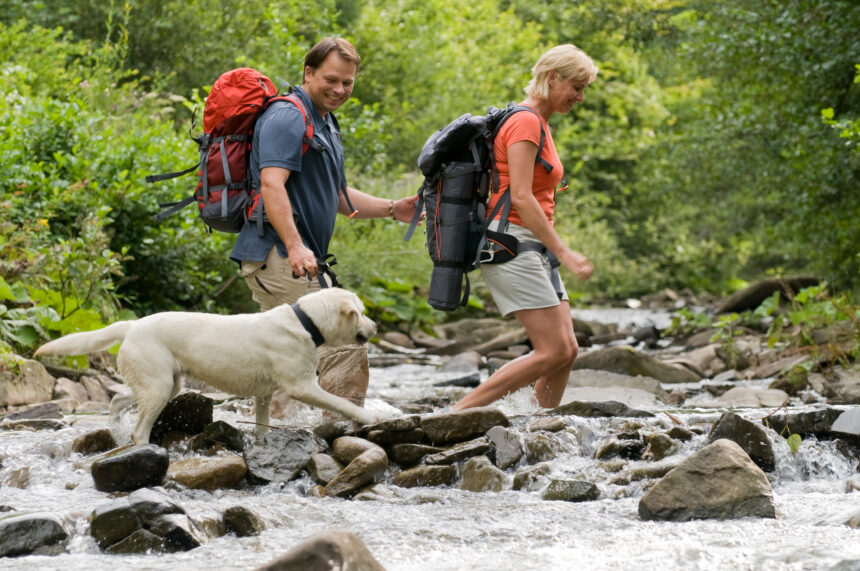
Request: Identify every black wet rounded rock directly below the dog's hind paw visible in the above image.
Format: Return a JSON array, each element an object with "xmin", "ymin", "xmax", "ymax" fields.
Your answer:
[{"xmin": 91, "ymin": 444, "xmax": 170, "ymax": 492}]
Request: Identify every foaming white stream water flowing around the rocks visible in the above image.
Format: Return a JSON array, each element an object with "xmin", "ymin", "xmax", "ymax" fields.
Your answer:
[{"xmin": 0, "ymin": 312, "xmax": 860, "ymax": 571}]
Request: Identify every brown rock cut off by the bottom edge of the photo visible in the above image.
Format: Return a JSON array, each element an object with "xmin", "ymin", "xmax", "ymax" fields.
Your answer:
[{"xmin": 257, "ymin": 529, "xmax": 385, "ymax": 571}]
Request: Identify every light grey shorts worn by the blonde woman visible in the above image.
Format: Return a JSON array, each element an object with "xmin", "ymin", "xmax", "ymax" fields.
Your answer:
[{"xmin": 481, "ymin": 222, "xmax": 568, "ymax": 316}]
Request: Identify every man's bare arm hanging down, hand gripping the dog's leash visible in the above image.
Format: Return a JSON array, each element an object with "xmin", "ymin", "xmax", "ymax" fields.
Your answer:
[{"xmin": 260, "ymin": 167, "xmax": 319, "ymax": 277}]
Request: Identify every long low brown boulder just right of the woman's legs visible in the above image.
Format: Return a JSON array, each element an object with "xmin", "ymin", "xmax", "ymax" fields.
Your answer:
[{"xmin": 573, "ymin": 347, "xmax": 700, "ymax": 383}]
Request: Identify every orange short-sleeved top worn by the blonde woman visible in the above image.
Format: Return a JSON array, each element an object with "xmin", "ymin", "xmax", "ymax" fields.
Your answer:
[{"xmin": 487, "ymin": 106, "xmax": 564, "ymax": 226}]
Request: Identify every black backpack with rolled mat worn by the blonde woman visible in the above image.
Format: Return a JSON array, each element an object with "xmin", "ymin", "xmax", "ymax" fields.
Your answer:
[{"xmin": 404, "ymin": 103, "xmax": 552, "ymax": 311}]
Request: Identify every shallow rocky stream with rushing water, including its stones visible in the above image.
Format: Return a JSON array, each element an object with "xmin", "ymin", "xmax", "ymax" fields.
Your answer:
[{"xmin": 0, "ymin": 284, "xmax": 860, "ymax": 571}]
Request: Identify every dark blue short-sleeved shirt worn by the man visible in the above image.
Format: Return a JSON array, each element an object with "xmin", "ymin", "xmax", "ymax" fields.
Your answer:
[{"xmin": 230, "ymin": 88, "xmax": 346, "ymax": 262}]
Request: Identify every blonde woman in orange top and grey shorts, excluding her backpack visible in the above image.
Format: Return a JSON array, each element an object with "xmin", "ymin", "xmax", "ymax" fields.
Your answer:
[{"xmin": 452, "ymin": 44, "xmax": 597, "ymax": 410}]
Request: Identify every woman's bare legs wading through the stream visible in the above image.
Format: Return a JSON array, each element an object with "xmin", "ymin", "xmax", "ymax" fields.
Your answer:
[{"xmin": 451, "ymin": 301, "xmax": 579, "ymax": 410}]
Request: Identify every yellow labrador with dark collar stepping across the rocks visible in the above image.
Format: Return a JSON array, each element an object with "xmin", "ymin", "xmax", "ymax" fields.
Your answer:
[{"xmin": 36, "ymin": 288, "xmax": 379, "ymax": 444}]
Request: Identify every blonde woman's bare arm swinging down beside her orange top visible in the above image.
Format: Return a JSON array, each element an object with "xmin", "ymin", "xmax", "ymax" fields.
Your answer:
[{"xmin": 508, "ymin": 141, "xmax": 594, "ymax": 280}]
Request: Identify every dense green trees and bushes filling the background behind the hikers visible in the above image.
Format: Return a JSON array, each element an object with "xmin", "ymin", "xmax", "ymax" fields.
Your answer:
[{"xmin": 0, "ymin": 0, "xmax": 860, "ymax": 359}]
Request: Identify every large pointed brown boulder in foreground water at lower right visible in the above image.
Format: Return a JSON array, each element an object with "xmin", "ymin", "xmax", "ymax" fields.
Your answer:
[{"xmin": 639, "ymin": 439, "xmax": 776, "ymax": 521}]
